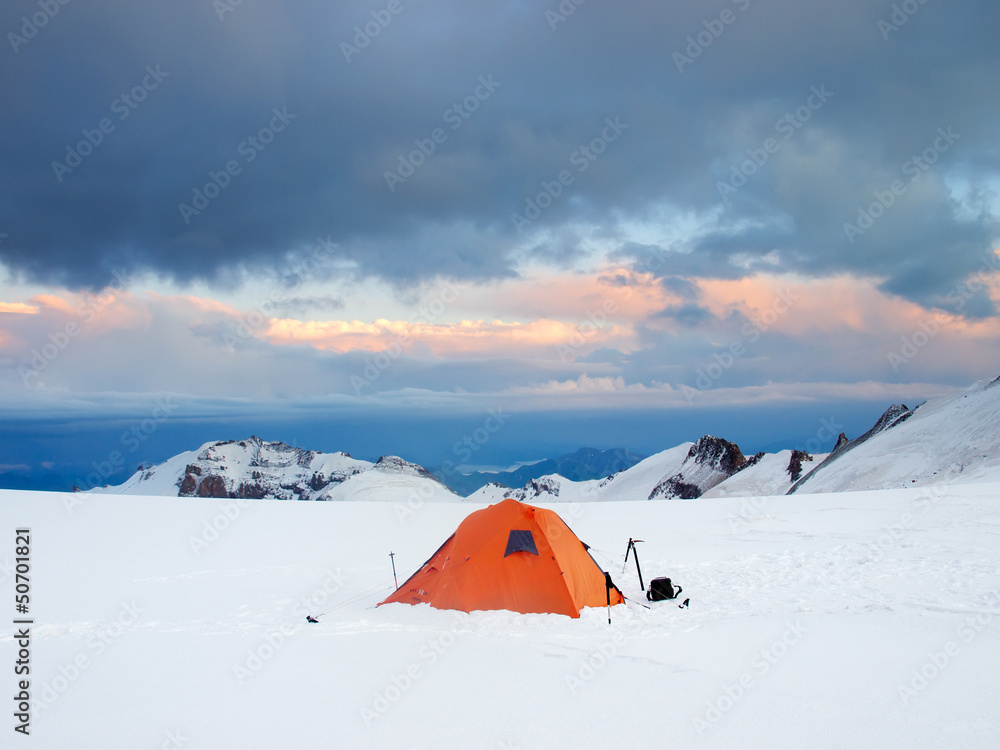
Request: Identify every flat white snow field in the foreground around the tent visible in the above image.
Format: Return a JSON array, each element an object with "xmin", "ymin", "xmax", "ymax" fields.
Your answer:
[{"xmin": 0, "ymin": 484, "xmax": 1000, "ymax": 750}]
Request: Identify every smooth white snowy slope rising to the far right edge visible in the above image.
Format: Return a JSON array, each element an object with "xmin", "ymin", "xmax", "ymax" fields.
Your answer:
[{"xmin": 794, "ymin": 378, "xmax": 1000, "ymax": 494}]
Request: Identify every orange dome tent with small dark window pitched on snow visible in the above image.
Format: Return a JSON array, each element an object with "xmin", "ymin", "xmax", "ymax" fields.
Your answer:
[{"xmin": 380, "ymin": 498, "xmax": 624, "ymax": 617}]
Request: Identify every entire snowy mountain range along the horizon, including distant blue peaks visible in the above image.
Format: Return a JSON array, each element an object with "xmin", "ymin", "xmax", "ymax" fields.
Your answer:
[{"xmin": 90, "ymin": 378, "xmax": 1000, "ymax": 507}]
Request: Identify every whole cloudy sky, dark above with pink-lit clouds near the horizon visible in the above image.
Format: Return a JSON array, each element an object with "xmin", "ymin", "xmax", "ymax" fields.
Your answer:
[{"xmin": 0, "ymin": 0, "xmax": 1000, "ymax": 489}]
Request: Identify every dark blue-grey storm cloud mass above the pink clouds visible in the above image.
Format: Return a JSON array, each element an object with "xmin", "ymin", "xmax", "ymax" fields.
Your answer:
[{"xmin": 0, "ymin": 0, "xmax": 1000, "ymax": 308}]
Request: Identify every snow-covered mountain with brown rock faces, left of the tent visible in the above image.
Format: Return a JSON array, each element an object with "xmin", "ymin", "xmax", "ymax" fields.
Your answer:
[{"xmin": 89, "ymin": 437, "xmax": 461, "ymax": 502}]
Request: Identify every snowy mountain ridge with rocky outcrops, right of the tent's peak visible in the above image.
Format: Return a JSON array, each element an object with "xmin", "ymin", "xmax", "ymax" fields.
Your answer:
[{"xmin": 468, "ymin": 378, "xmax": 1000, "ymax": 503}]
